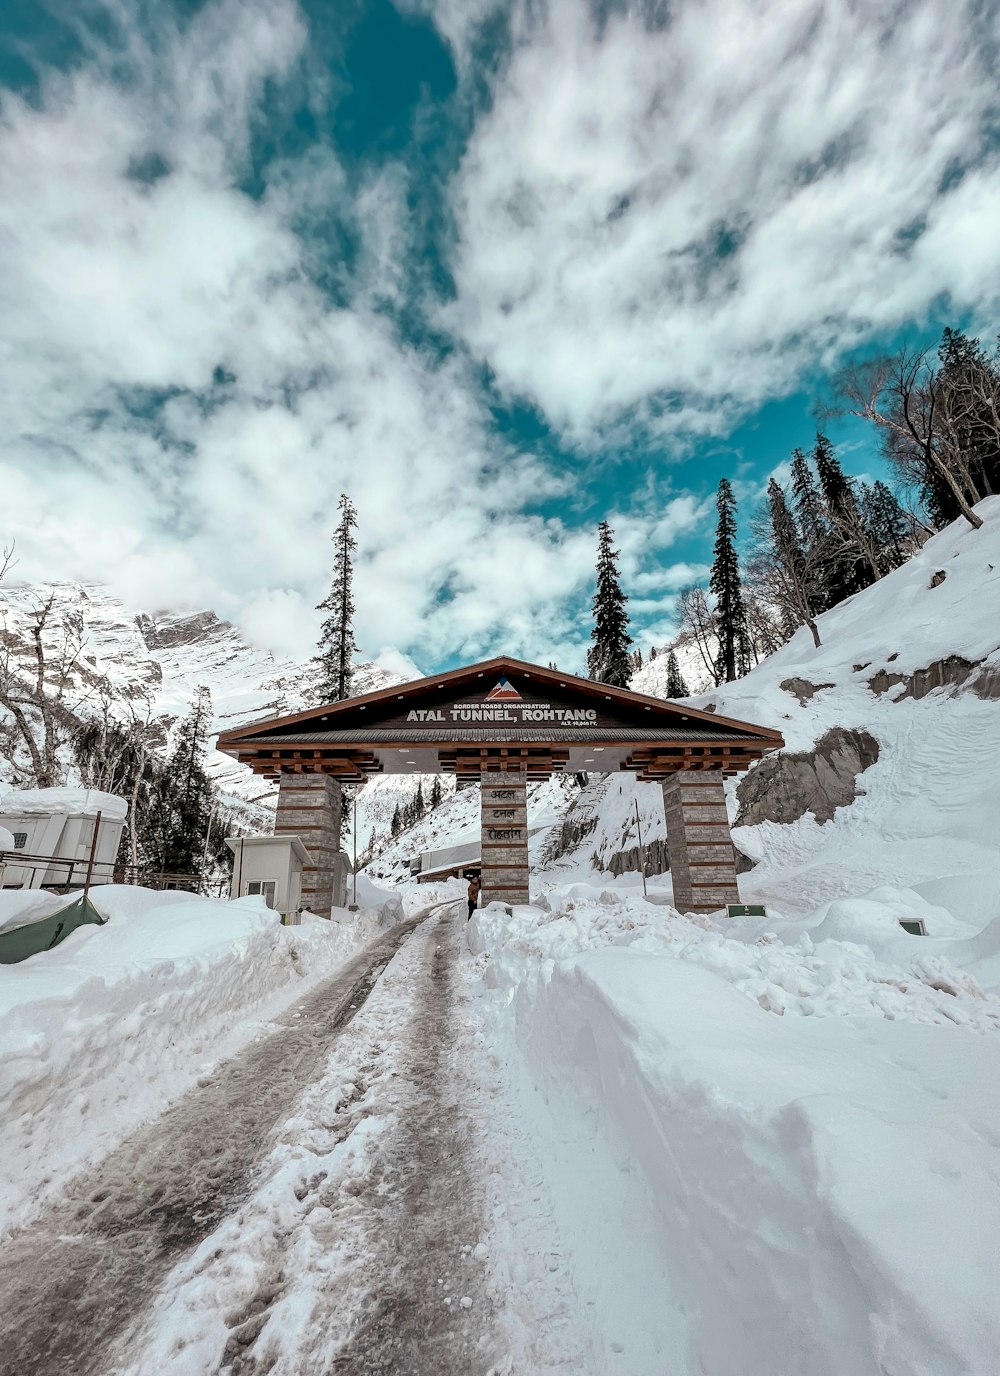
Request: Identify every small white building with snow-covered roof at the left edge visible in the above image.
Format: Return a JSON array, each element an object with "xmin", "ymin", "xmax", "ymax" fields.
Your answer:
[{"xmin": 0, "ymin": 784, "xmax": 128, "ymax": 889}]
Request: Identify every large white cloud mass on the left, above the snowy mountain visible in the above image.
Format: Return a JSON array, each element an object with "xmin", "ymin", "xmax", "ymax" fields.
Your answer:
[{"xmin": 0, "ymin": 0, "xmax": 696, "ymax": 665}]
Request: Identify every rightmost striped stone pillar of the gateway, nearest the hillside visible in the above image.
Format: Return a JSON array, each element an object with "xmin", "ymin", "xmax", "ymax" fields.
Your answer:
[{"xmin": 663, "ymin": 769, "xmax": 740, "ymax": 912}]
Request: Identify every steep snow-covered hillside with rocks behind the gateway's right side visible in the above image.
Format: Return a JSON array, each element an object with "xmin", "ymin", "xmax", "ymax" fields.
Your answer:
[{"xmin": 561, "ymin": 497, "xmax": 1000, "ymax": 925}]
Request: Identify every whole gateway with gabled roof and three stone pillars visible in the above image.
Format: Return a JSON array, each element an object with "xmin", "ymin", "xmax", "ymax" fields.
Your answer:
[{"xmin": 219, "ymin": 656, "xmax": 784, "ymax": 914}]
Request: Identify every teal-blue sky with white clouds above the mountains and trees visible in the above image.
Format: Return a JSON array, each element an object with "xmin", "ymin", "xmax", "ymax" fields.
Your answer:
[{"xmin": 0, "ymin": 0, "xmax": 1000, "ymax": 670}]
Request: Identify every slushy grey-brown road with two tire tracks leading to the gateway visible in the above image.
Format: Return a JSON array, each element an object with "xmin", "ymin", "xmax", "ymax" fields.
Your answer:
[{"xmin": 0, "ymin": 908, "xmax": 492, "ymax": 1376}]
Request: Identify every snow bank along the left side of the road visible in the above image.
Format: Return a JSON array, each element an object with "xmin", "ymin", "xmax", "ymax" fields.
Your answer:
[{"xmin": 0, "ymin": 885, "xmax": 399, "ymax": 1229}]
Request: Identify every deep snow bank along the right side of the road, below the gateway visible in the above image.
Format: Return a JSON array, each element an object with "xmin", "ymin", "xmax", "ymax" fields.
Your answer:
[{"xmin": 470, "ymin": 885, "xmax": 1000, "ymax": 1376}]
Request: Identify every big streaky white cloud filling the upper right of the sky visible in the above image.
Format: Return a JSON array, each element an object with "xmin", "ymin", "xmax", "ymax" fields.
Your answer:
[{"xmin": 447, "ymin": 0, "xmax": 1000, "ymax": 442}]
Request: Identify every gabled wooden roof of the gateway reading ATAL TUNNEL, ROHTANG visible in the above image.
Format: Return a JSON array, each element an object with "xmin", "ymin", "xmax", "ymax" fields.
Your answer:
[{"xmin": 219, "ymin": 655, "xmax": 784, "ymax": 780}]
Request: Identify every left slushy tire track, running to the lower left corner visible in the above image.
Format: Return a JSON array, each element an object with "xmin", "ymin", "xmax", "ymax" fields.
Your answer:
[{"xmin": 0, "ymin": 905, "xmax": 440, "ymax": 1376}]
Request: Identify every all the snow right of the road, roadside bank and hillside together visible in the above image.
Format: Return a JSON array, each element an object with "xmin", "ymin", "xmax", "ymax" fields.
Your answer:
[{"xmin": 470, "ymin": 498, "xmax": 1000, "ymax": 1376}]
